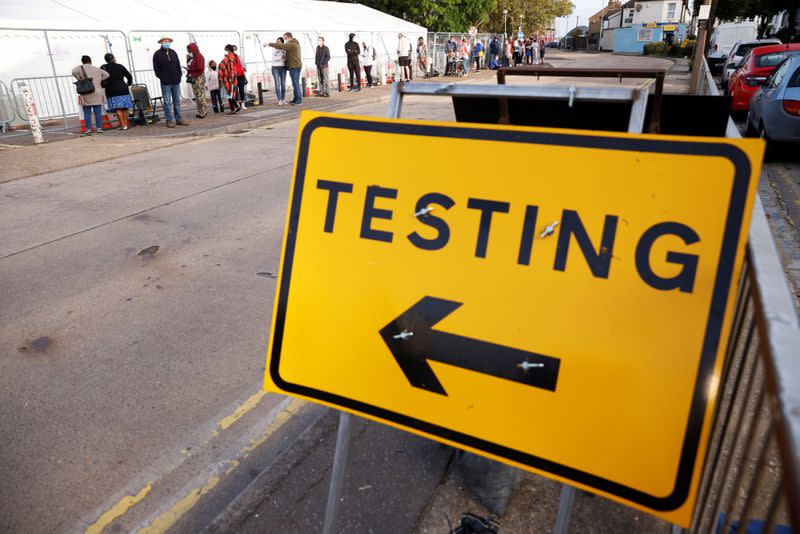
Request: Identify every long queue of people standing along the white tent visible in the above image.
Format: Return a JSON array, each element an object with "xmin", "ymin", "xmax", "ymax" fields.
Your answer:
[{"xmin": 72, "ymin": 32, "xmax": 512, "ymax": 135}]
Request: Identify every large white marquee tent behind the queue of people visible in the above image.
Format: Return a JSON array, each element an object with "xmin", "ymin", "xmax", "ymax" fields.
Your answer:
[{"xmin": 0, "ymin": 0, "xmax": 427, "ymax": 121}]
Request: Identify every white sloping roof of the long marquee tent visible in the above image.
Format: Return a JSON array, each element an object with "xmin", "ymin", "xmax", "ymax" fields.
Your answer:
[{"xmin": 0, "ymin": 0, "xmax": 427, "ymax": 33}]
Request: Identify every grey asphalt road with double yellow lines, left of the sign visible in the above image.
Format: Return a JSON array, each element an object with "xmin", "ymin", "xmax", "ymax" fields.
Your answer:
[{"xmin": 0, "ymin": 51, "xmax": 688, "ymax": 532}]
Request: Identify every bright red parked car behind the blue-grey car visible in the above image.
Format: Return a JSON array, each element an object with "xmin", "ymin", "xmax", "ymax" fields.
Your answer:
[{"xmin": 728, "ymin": 43, "xmax": 800, "ymax": 111}]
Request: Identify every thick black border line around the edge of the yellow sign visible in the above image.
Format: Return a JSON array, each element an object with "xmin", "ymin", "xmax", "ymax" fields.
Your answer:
[{"xmin": 269, "ymin": 116, "xmax": 751, "ymax": 511}]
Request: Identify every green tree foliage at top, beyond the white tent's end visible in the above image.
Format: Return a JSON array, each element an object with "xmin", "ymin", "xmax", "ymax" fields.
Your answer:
[{"xmin": 340, "ymin": 0, "xmax": 573, "ymax": 33}]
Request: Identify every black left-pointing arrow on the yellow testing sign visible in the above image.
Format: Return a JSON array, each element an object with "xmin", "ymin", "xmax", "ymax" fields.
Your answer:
[{"xmin": 380, "ymin": 297, "xmax": 561, "ymax": 395}]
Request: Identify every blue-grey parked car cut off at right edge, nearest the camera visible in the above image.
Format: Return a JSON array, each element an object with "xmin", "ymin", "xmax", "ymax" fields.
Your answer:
[{"xmin": 747, "ymin": 54, "xmax": 800, "ymax": 143}]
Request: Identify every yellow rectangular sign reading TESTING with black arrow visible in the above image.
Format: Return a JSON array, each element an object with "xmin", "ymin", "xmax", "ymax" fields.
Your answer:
[{"xmin": 265, "ymin": 112, "xmax": 764, "ymax": 526}]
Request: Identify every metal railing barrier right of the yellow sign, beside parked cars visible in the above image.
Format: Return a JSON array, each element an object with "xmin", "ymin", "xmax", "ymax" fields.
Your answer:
[{"xmin": 680, "ymin": 55, "xmax": 800, "ymax": 534}]
